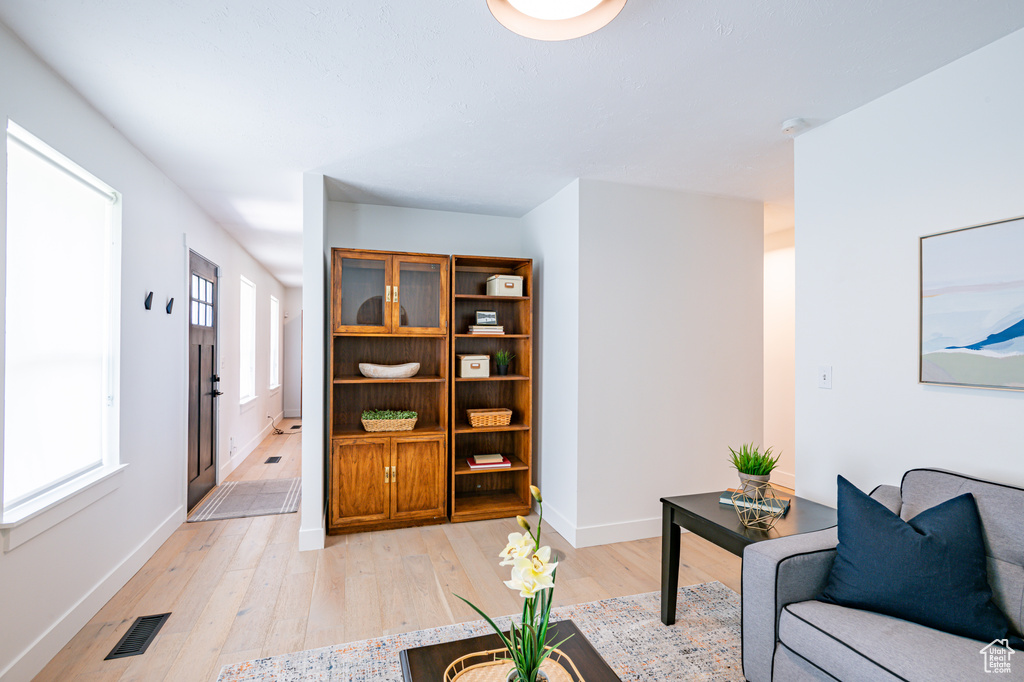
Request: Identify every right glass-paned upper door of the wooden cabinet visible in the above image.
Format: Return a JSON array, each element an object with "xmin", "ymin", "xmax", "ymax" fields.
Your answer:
[{"xmin": 391, "ymin": 255, "xmax": 449, "ymax": 334}]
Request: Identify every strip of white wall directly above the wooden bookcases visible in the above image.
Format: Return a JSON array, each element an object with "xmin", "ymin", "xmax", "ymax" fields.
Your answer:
[{"xmin": 327, "ymin": 202, "xmax": 523, "ymax": 258}]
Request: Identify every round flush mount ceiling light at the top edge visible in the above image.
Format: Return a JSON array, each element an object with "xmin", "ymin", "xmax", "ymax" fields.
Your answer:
[{"xmin": 487, "ymin": 0, "xmax": 626, "ymax": 40}]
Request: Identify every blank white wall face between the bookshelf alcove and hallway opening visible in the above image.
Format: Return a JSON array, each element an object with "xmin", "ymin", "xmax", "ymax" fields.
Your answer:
[{"xmin": 577, "ymin": 180, "xmax": 764, "ymax": 546}]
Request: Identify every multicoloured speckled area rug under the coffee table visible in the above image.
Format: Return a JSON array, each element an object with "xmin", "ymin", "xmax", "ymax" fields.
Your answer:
[{"xmin": 217, "ymin": 583, "xmax": 743, "ymax": 682}]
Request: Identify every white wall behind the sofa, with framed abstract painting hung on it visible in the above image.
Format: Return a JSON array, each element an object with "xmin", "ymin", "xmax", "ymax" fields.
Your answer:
[{"xmin": 796, "ymin": 31, "xmax": 1024, "ymax": 502}]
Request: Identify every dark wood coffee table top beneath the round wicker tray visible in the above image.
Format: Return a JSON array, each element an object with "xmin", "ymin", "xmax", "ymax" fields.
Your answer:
[{"xmin": 398, "ymin": 621, "xmax": 621, "ymax": 682}]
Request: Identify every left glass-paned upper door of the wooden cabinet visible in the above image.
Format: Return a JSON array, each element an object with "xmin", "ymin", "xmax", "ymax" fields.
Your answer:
[{"xmin": 331, "ymin": 251, "xmax": 391, "ymax": 334}]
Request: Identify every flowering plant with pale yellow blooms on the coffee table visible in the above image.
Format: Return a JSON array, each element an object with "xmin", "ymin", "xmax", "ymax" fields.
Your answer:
[{"xmin": 456, "ymin": 485, "xmax": 567, "ymax": 682}]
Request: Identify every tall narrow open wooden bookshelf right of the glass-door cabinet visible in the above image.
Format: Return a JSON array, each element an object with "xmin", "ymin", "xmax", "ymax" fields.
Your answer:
[{"xmin": 449, "ymin": 256, "xmax": 534, "ymax": 521}]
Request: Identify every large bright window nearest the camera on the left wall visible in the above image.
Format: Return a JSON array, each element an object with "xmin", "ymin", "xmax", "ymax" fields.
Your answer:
[{"xmin": 3, "ymin": 122, "xmax": 121, "ymax": 512}]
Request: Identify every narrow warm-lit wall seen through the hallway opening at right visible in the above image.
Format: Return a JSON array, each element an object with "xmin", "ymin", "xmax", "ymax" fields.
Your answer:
[{"xmin": 763, "ymin": 227, "xmax": 797, "ymax": 488}]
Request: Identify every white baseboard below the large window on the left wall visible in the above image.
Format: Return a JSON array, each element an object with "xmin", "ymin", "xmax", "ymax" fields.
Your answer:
[{"xmin": 0, "ymin": 507, "xmax": 185, "ymax": 682}]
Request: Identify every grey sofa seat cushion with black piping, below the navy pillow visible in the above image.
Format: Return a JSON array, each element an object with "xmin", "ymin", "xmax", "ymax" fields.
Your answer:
[{"xmin": 776, "ymin": 601, "xmax": 1024, "ymax": 682}]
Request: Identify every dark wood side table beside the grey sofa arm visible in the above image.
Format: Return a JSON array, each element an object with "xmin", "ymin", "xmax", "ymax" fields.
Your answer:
[{"xmin": 662, "ymin": 491, "xmax": 836, "ymax": 625}]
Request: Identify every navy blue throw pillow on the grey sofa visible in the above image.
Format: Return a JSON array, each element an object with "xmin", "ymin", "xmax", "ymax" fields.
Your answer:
[{"xmin": 818, "ymin": 476, "xmax": 1022, "ymax": 648}]
